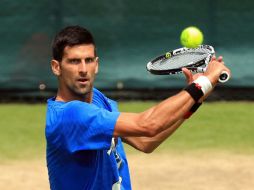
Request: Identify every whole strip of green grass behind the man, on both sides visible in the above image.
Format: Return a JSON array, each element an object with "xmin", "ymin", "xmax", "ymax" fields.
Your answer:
[{"xmin": 0, "ymin": 102, "xmax": 254, "ymax": 160}]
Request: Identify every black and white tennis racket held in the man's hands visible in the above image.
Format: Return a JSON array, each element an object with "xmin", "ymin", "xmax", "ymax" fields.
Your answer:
[{"xmin": 146, "ymin": 45, "xmax": 230, "ymax": 83}]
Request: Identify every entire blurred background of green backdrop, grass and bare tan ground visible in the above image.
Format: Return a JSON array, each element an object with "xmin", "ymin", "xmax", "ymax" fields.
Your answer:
[{"xmin": 0, "ymin": 0, "xmax": 254, "ymax": 190}]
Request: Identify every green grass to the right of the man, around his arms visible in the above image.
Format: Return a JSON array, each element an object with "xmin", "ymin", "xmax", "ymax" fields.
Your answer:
[{"xmin": 120, "ymin": 102, "xmax": 254, "ymax": 154}]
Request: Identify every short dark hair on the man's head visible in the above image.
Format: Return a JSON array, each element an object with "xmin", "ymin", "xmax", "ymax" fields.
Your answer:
[{"xmin": 52, "ymin": 26, "xmax": 96, "ymax": 61}]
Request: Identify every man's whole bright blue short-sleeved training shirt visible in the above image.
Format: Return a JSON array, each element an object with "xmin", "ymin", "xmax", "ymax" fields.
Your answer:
[{"xmin": 45, "ymin": 88, "xmax": 131, "ymax": 190}]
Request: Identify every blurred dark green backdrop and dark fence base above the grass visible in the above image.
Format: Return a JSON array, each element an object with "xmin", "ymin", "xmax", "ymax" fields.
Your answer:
[{"xmin": 0, "ymin": 0, "xmax": 254, "ymax": 102}]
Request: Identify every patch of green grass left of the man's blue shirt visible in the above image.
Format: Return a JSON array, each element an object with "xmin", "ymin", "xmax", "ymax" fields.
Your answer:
[{"xmin": 0, "ymin": 104, "xmax": 46, "ymax": 159}]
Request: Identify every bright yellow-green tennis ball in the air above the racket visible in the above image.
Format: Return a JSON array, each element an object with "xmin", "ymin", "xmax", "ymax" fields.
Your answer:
[{"xmin": 180, "ymin": 26, "xmax": 204, "ymax": 48}]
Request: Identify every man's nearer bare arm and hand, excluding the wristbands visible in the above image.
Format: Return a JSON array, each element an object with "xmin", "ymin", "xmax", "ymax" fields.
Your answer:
[{"xmin": 114, "ymin": 57, "xmax": 230, "ymax": 137}]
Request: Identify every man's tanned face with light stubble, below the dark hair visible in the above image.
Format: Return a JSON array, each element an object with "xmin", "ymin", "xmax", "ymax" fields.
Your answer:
[{"xmin": 53, "ymin": 44, "xmax": 98, "ymax": 99}]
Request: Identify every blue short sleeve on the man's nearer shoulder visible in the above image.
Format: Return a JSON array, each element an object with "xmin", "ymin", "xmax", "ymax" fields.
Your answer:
[{"xmin": 61, "ymin": 101, "xmax": 119, "ymax": 153}]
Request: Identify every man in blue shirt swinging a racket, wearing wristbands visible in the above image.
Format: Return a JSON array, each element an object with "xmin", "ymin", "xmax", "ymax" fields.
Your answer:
[{"xmin": 45, "ymin": 26, "xmax": 230, "ymax": 190}]
